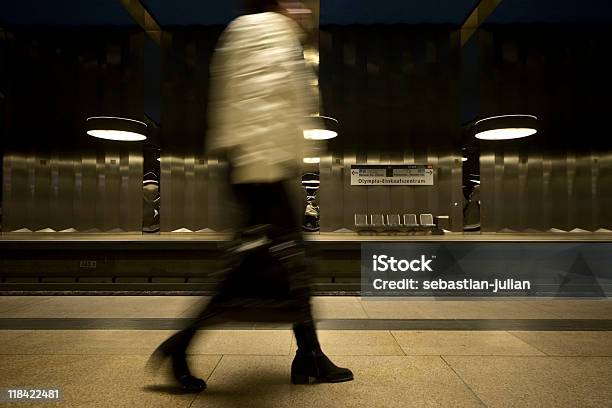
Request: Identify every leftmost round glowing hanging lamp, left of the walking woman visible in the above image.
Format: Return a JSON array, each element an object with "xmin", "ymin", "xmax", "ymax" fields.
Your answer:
[{"xmin": 86, "ymin": 116, "xmax": 147, "ymax": 142}]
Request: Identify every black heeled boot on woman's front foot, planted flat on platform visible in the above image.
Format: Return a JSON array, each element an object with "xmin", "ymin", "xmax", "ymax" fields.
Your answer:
[{"xmin": 291, "ymin": 322, "xmax": 353, "ymax": 384}]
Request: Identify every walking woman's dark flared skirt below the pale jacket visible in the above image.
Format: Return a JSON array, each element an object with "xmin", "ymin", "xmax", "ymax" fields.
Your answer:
[{"xmin": 191, "ymin": 182, "xmax": 312, "ymax": 323}]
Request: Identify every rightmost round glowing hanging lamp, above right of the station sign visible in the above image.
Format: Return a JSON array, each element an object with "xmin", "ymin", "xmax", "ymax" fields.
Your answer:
[{"xmin": 474, "ymin": 115, "xmax": 538, "ymax": 140}]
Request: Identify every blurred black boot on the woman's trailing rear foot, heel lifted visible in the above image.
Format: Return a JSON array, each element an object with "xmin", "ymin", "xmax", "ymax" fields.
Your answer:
[{"xmin": 147, "ymin": 331, "xmax": 206, "ymax": 393}]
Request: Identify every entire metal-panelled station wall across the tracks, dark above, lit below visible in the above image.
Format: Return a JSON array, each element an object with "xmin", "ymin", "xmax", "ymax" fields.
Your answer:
[{"xmin": 0, "ymin": 24, "xmax": 612, "ymax": 232}]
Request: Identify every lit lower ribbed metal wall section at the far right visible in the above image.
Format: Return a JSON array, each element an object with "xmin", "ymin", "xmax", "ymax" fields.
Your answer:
[{"xmin": 480, "ymin": 148, "xmax": 612, "ymax": 232}]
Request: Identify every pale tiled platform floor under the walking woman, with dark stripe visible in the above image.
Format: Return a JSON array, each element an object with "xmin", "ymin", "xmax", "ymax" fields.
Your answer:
[{"xmin": 0, "ymin": 296, "xmax": 612, "ymax": 407}]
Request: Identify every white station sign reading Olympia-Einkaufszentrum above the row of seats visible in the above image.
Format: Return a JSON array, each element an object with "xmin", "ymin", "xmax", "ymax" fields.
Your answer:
[{"xmin": 351, "ymin": 164, "xmax": 434, "ymax": 186}]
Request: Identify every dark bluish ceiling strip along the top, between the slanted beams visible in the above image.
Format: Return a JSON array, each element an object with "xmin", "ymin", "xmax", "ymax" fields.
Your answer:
[{"xmin": 0, "ymin": 0, "xmax": 612, "ymax": 26}]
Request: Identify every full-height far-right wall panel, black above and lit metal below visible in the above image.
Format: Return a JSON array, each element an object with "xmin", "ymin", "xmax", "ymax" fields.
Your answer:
[{"xmin": 474, "ymin": 23, "xmax": 612, "ymax": 232}]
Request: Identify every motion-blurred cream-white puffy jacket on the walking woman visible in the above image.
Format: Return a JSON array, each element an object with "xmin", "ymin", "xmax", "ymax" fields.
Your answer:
[{"xmin": 207, "ymin": 12, "xmax": 318, "ymax": 183}]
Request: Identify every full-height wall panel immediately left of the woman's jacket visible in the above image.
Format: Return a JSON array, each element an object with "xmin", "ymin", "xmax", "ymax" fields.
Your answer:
[{"xmin": 160, "ymin": 26, "xmax": 233, "ymax": 232}]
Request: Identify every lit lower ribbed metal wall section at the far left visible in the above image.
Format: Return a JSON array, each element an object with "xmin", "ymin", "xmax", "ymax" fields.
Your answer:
[{"xmin": 2, "ymin": 150, "xmax": 142, "ymax": 232}]
